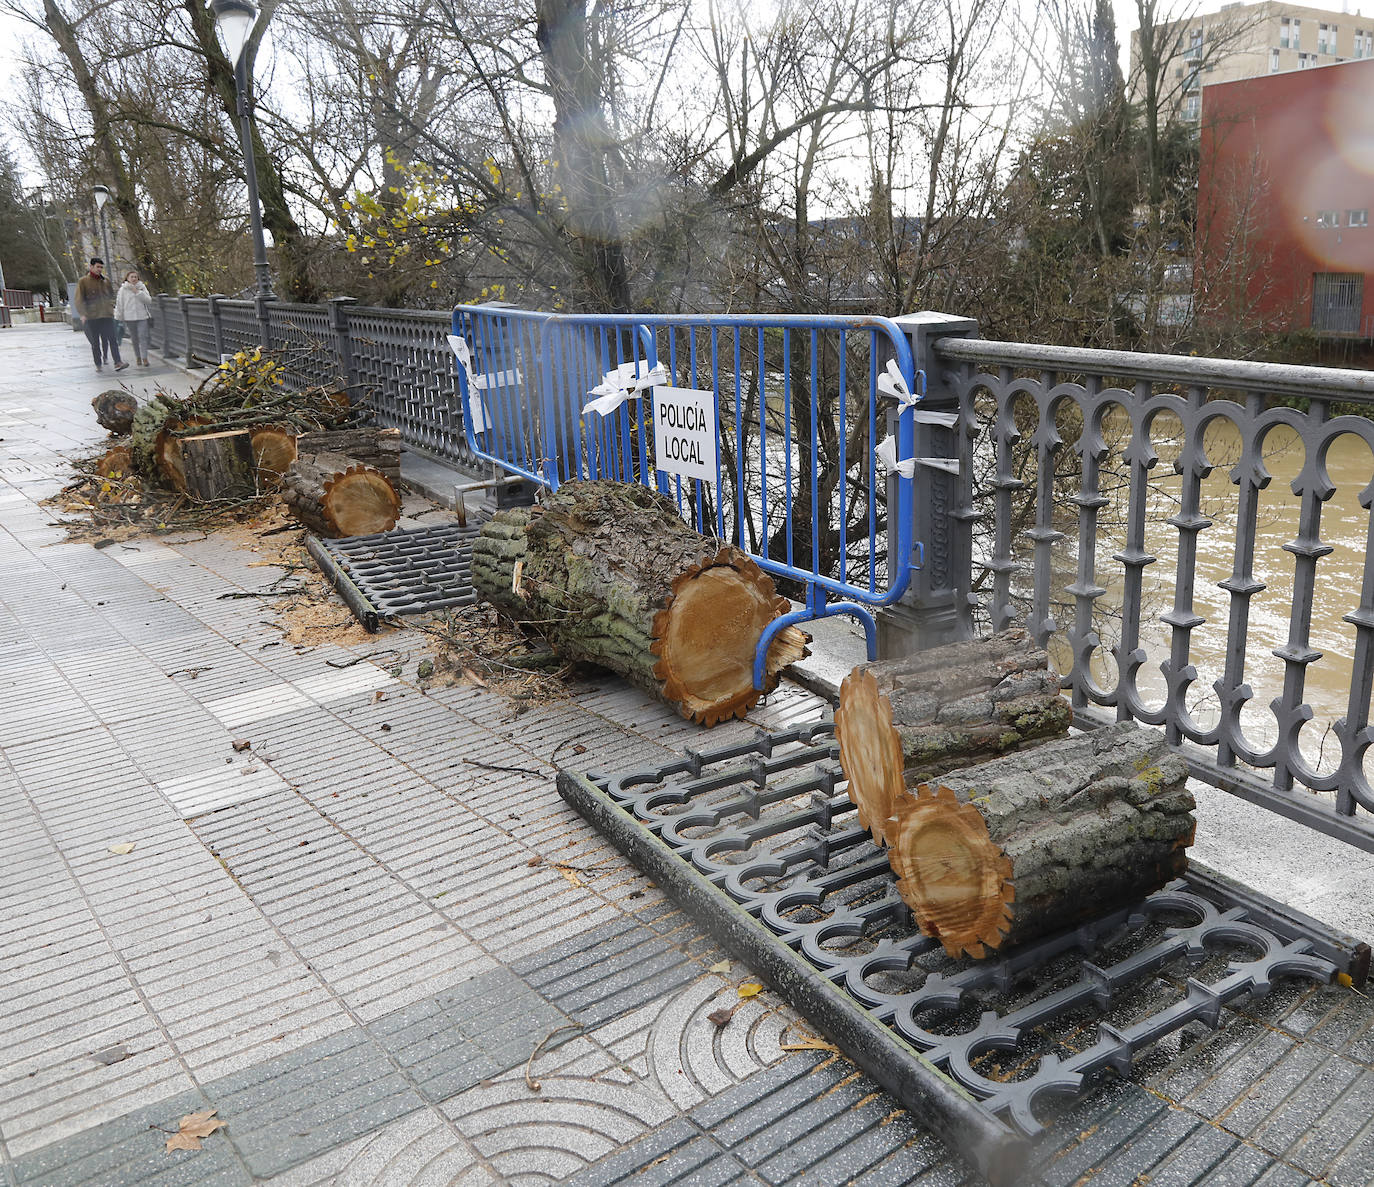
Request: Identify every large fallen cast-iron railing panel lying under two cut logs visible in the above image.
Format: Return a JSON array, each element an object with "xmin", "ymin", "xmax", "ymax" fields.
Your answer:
[{"xmin": 559, "ymin": 721, "xmax": 1338, "ymax": 1136}]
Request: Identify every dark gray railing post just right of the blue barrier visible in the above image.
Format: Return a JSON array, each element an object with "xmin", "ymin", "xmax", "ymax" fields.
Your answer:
[{"xmin": 878, "ymin": 312, "xmax": 978, "ymax": 659}]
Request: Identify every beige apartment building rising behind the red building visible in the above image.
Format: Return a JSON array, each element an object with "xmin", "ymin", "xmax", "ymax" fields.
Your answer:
[{"xmin": 1131, "ymin": 0, "xmax": 1374, "ymax": 122}]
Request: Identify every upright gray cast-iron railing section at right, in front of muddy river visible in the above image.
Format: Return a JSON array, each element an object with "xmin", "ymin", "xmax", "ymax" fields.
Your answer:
[{"xmin": 897, "ymin": 319, "xmax": 1374, "ymax": 850}]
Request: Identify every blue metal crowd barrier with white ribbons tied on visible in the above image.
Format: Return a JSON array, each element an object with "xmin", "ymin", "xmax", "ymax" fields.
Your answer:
[{"xmin": 453, "ymin": 306, "xmax": 923, "ymax": 687}]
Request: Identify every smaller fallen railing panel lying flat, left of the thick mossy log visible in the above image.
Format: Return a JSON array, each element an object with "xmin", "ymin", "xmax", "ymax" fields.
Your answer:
[{"xmin": 306, "ymin": 523, "xmax": 481, "ymax": 631}]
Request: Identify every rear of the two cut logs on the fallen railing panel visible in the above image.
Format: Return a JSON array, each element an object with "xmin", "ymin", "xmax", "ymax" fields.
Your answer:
[{"xmin": 835, "ymin": 631, "xmax": 1073, "ymax": 844}]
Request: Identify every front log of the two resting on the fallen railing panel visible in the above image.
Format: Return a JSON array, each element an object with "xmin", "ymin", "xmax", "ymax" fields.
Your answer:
[{"xmin": 885, "ymin": 723, "xmax": 1195, "ymax": 958}]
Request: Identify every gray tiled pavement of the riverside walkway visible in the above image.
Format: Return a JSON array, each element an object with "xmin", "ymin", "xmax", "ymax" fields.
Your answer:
[{"xmin": 0, "ymin": 317, "xmax": 1374, "ymax": 1187}]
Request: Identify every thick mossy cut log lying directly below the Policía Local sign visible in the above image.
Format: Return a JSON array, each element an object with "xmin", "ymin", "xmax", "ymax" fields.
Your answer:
[{"xmin": 473, "ymin": 481, "xmax": 809, "ymax": 725}]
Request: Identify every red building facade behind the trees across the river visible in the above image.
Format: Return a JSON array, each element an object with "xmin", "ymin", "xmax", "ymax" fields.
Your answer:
[{"xmin": 1195, "ymin": 59, "xmax": 1374, "ymax": 338}]
